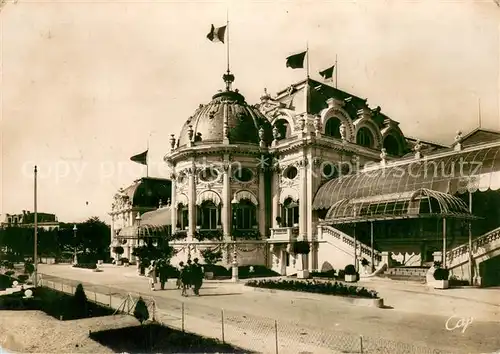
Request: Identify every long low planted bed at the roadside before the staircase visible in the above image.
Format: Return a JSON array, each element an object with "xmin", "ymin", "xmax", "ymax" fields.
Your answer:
[{"xmin": 246, "ymin": 280, "xmax": 378, "ymax": 299}]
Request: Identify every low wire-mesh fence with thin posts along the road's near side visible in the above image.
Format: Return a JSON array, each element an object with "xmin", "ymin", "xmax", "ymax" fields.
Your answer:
[{"xmin": 40, "ymin": 276, "xmax": 459, "ymax": 354}]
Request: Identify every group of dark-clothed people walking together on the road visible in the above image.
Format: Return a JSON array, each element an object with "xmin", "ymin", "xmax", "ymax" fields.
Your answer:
[{"xmin": 148, "ymin": 258, "xmax": 205, "ymax": 296}]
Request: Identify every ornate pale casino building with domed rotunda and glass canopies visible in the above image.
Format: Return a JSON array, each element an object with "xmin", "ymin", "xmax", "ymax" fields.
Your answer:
[{"xmin": 111, "ymin": 73, "xmax": 500, "ymax": 286}]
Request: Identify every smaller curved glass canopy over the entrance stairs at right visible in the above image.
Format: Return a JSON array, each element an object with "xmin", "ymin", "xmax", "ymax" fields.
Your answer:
[{"xmin": 325, "ymin": 188, "xmax": 473, "ymax": 224}]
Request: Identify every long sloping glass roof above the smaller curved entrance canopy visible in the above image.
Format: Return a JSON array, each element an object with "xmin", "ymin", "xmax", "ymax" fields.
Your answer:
[{"xmin": 313, "ymin": 143, "xmax": 500, "ymax": 210}]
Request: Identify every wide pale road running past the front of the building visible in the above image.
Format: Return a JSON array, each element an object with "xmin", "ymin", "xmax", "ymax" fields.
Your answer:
[{"xmin": 39, "ymin": 265, "xmax": 500, "ymax": 353}]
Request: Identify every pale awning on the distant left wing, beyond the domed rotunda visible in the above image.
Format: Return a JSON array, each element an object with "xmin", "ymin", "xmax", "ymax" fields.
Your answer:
[{"xmin": 117, "ymin": 207, "xmax": 172, "ymax": 238}]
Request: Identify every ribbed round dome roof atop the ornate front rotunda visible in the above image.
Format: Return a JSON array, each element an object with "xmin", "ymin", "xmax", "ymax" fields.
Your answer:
[{"xmin": 177, "ymin": 89, "xmax": 273, "ymax": 147}]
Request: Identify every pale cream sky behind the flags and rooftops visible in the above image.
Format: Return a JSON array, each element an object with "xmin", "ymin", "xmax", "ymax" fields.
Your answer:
[{"xmin": 0, "ymin": 0, "xmax": 500, "ymax": 222}]
